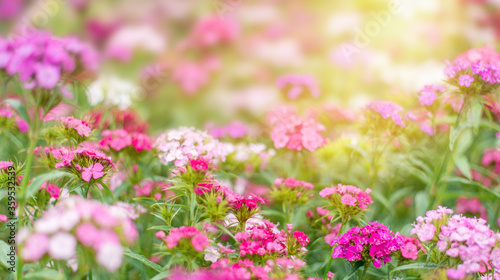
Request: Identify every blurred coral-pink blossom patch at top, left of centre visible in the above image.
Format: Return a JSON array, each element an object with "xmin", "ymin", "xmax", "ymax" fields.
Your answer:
[{"xmin": 190, "ymin": 15, "xmax": 239, "ymax": 47}]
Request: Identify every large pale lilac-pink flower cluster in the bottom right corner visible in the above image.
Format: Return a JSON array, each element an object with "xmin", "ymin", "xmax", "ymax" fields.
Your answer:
[{"xmin": 437, "ymin": 215, "xmax": 500, "ymax": 279}]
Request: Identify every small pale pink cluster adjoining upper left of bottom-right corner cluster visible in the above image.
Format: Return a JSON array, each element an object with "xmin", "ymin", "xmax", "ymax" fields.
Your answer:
[{"xmin": 410, "ymin": 206, "xmax": 453, "ymax": 242}]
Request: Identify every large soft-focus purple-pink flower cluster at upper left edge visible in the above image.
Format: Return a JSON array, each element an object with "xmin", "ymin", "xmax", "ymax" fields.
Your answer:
[{"xmin": 0, "ymin": 32, "xmax": 97, "ymax": 89}]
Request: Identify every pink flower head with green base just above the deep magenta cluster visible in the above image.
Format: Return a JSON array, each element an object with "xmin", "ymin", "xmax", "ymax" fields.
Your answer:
[{"xmin": 319, "ymin": 184, "xmax": 373, "ymax": 220}]
